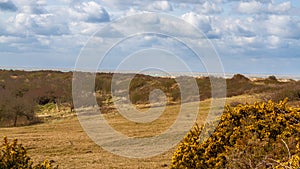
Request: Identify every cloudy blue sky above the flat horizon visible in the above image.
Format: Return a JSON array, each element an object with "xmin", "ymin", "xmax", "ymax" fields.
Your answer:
[{"xmin": 0, "ymin": 0, "xmax": 300, "ymax": 75}]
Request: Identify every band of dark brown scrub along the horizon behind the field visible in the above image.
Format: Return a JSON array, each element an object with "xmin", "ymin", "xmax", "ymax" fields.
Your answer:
[{"xmin": 0, "ymin": 70, "xmax": 300, "ymax": 126}]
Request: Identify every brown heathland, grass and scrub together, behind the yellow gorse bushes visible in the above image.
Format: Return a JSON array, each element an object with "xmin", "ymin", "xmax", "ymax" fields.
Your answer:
[{"xmin": 0, "ymin": 70, "xmax": 300, "ymax": 169}]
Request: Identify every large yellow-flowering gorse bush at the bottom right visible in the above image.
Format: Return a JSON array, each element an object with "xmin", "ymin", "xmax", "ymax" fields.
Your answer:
[{"xmin": 171, "ymin": 99, "xmax": 300, "ymax": 169}]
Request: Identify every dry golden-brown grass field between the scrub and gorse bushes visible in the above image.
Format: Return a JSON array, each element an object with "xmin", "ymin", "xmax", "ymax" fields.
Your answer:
[{"xmin": 0, "ymin": 95, "xmax": 257, "ymax": 169}]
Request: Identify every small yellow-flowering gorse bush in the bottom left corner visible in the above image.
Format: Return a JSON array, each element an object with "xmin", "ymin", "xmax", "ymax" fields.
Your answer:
[{"xmin": 0, "ymin": 137, "xmax": 58, "ymax": 169}]
